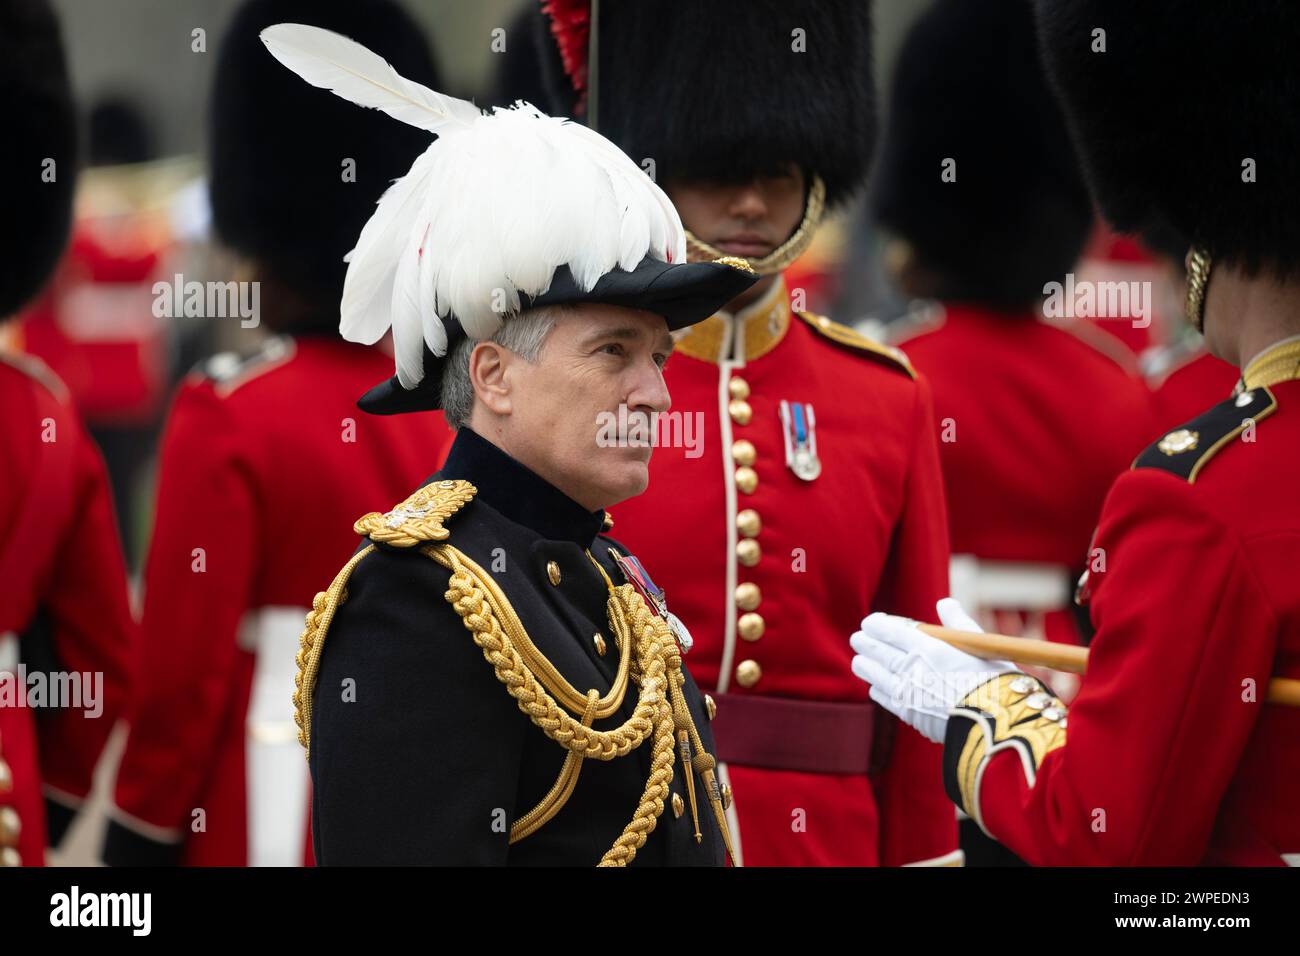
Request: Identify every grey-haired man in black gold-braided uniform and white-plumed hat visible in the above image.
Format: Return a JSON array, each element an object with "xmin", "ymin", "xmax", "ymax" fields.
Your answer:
[{"xmin": 263, "ymin": 23, "xmax": 754, "ymax": 866}]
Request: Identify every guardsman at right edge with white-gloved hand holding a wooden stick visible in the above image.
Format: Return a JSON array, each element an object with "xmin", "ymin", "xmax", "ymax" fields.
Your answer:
[{"xmin": 852, "ymin": 0, "xmax": 1300, "ymax": 866}]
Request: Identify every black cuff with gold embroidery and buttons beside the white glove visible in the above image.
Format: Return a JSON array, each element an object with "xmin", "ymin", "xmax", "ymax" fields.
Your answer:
[{"xmin": 944, "ymin": 671, "xmax": 1066, "ymax": 835}]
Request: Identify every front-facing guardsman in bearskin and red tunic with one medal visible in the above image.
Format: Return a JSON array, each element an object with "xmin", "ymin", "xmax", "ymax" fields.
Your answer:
[{"xmin": 540, "ymin": 1, "xmax": 959, "ymax": 866}]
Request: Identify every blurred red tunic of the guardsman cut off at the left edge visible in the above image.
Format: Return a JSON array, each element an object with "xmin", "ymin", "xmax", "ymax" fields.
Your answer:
[{"xmin": 0, "ymin": 356, "xmax": 135, "ymax": 865}]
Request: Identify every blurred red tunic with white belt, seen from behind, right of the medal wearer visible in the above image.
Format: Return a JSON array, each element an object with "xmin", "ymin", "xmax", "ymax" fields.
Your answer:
[{"xmin": 900, "ymin": 304, "xmax": 1156, "ymax": 671}]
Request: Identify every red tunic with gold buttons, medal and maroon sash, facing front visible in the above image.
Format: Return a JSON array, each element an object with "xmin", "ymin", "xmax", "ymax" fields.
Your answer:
[{"xmin": 611, "ymin": 277, "xmax": 957, "ymax": 866}]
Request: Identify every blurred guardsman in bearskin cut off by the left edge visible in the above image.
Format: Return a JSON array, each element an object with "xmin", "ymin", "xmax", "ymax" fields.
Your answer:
[{"xmin": 0, "ymin": 0, "xmax": 134, "ymax": 866}]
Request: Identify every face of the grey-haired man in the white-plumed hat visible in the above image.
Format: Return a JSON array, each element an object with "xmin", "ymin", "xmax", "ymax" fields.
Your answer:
[{"xmin": 493, "ymin": 303, "xmax": 672, "ymax": 511}]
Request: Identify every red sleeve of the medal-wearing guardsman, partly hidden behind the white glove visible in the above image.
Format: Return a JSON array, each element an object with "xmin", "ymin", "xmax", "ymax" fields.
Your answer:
[{"xmin": 871, "ymin": 377, "xmax": 957, "ymax": 866}]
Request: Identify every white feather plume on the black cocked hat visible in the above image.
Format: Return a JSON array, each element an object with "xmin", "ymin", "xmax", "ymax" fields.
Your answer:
[{"xmin": 261, "ymin": 23, "xmax": 686, "ymax": 389}]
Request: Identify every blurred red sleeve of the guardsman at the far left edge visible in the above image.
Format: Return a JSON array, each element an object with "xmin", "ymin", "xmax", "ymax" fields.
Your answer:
[{"xmin": 38, "ymin": 423, "xmax": 137, "ymax": 809}]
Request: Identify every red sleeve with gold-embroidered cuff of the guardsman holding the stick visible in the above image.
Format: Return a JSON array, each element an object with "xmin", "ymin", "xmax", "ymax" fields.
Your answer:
[{"xmin": 946, "ymin": 470, "xmax": 1278, "ymax": 866}]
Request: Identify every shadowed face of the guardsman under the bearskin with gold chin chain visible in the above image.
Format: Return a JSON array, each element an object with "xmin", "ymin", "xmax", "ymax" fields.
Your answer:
[{"xmin": 666, "ymin": 163, "xmax": 805, "ymax": 259}]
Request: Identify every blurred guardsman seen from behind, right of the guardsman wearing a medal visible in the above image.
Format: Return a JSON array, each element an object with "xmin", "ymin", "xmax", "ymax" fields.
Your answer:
[{"xmin": 872, "ymin": 0, "xmax": 1154, "ymax": 865}]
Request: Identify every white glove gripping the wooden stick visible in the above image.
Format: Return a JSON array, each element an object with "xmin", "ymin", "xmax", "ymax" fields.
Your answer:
[{"xmin": 849, "ymin": 597, "xmax": 1019, "ymax": 744}]
